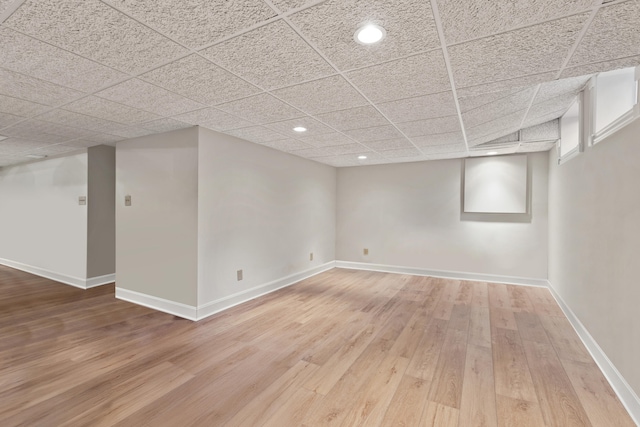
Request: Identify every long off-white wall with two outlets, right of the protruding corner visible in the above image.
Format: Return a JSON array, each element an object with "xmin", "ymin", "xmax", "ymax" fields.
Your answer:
[{"xmin": 198, "ymin": 128, "xmax": 336, "ymax": 305}]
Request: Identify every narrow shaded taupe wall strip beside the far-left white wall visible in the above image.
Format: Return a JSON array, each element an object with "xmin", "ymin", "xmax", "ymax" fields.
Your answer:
[{"xmin": 87, "ymin": 145, "xmax": 116, "ymax": 278}]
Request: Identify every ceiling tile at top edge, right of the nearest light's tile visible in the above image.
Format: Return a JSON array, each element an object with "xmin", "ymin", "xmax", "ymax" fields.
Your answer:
[{"xmin": 438, "ymin": 0, "xmax": 593, "ymax": 44}]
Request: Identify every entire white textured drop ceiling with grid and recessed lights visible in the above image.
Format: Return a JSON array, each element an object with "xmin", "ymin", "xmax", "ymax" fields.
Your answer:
[{"xmin": 0, "ymin": 0, "xmax": 640, "ymax": 167}]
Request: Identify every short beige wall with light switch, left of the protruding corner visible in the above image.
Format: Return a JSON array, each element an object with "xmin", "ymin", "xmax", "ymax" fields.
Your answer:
[{"xmin": 116, "ymin": 128, "xmax": 198, "ymax": 306}]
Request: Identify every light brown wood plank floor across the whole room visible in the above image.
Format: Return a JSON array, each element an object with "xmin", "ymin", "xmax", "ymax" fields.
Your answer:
[{"xmin": 0, "ymin": 266, "xmax": 634, "ymax": 427}]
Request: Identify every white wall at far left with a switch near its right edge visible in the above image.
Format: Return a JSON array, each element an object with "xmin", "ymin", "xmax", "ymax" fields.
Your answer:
[{"xmin": 0, "ymin": 150, "xmax": 87, "ymax": 285}]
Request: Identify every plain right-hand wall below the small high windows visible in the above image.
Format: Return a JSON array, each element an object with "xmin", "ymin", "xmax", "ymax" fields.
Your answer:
[{"xmin": 549, "ymin": 121, "xmax": 640, "ymax": 394}]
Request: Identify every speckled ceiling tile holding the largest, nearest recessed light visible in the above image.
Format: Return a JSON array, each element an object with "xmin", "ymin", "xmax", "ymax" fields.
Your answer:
[{"xmin": 290, "ymin": 0, "xmax": 440, "ymax": 70}]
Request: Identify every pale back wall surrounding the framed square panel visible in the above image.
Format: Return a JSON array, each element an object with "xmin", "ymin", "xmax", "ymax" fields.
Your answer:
[{"xmin": 336, "ymin": 153, "xmax": 548, "ymax": 279}]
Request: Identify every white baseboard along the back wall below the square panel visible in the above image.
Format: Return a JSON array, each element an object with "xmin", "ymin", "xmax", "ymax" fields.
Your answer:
[{"xmin": 336, "ymin": 261, "xmax": 548, "ymax": 288}]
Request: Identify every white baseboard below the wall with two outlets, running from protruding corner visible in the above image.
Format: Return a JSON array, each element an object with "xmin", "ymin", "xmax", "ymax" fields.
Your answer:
[{"xmin": 198, "ymin": 261, "xmax": 335, "ymax": 320}]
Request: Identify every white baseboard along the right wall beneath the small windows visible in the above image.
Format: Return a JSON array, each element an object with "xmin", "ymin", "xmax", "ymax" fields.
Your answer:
[{"xmin": 549, "ymin": 283, "xmax": 640, "ymax": 426}]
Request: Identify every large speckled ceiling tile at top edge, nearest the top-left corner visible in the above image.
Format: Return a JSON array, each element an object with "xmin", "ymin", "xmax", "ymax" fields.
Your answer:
[{"xmin": 5, "ymin": 0, "xmax": 188, "ymax": 73}]
